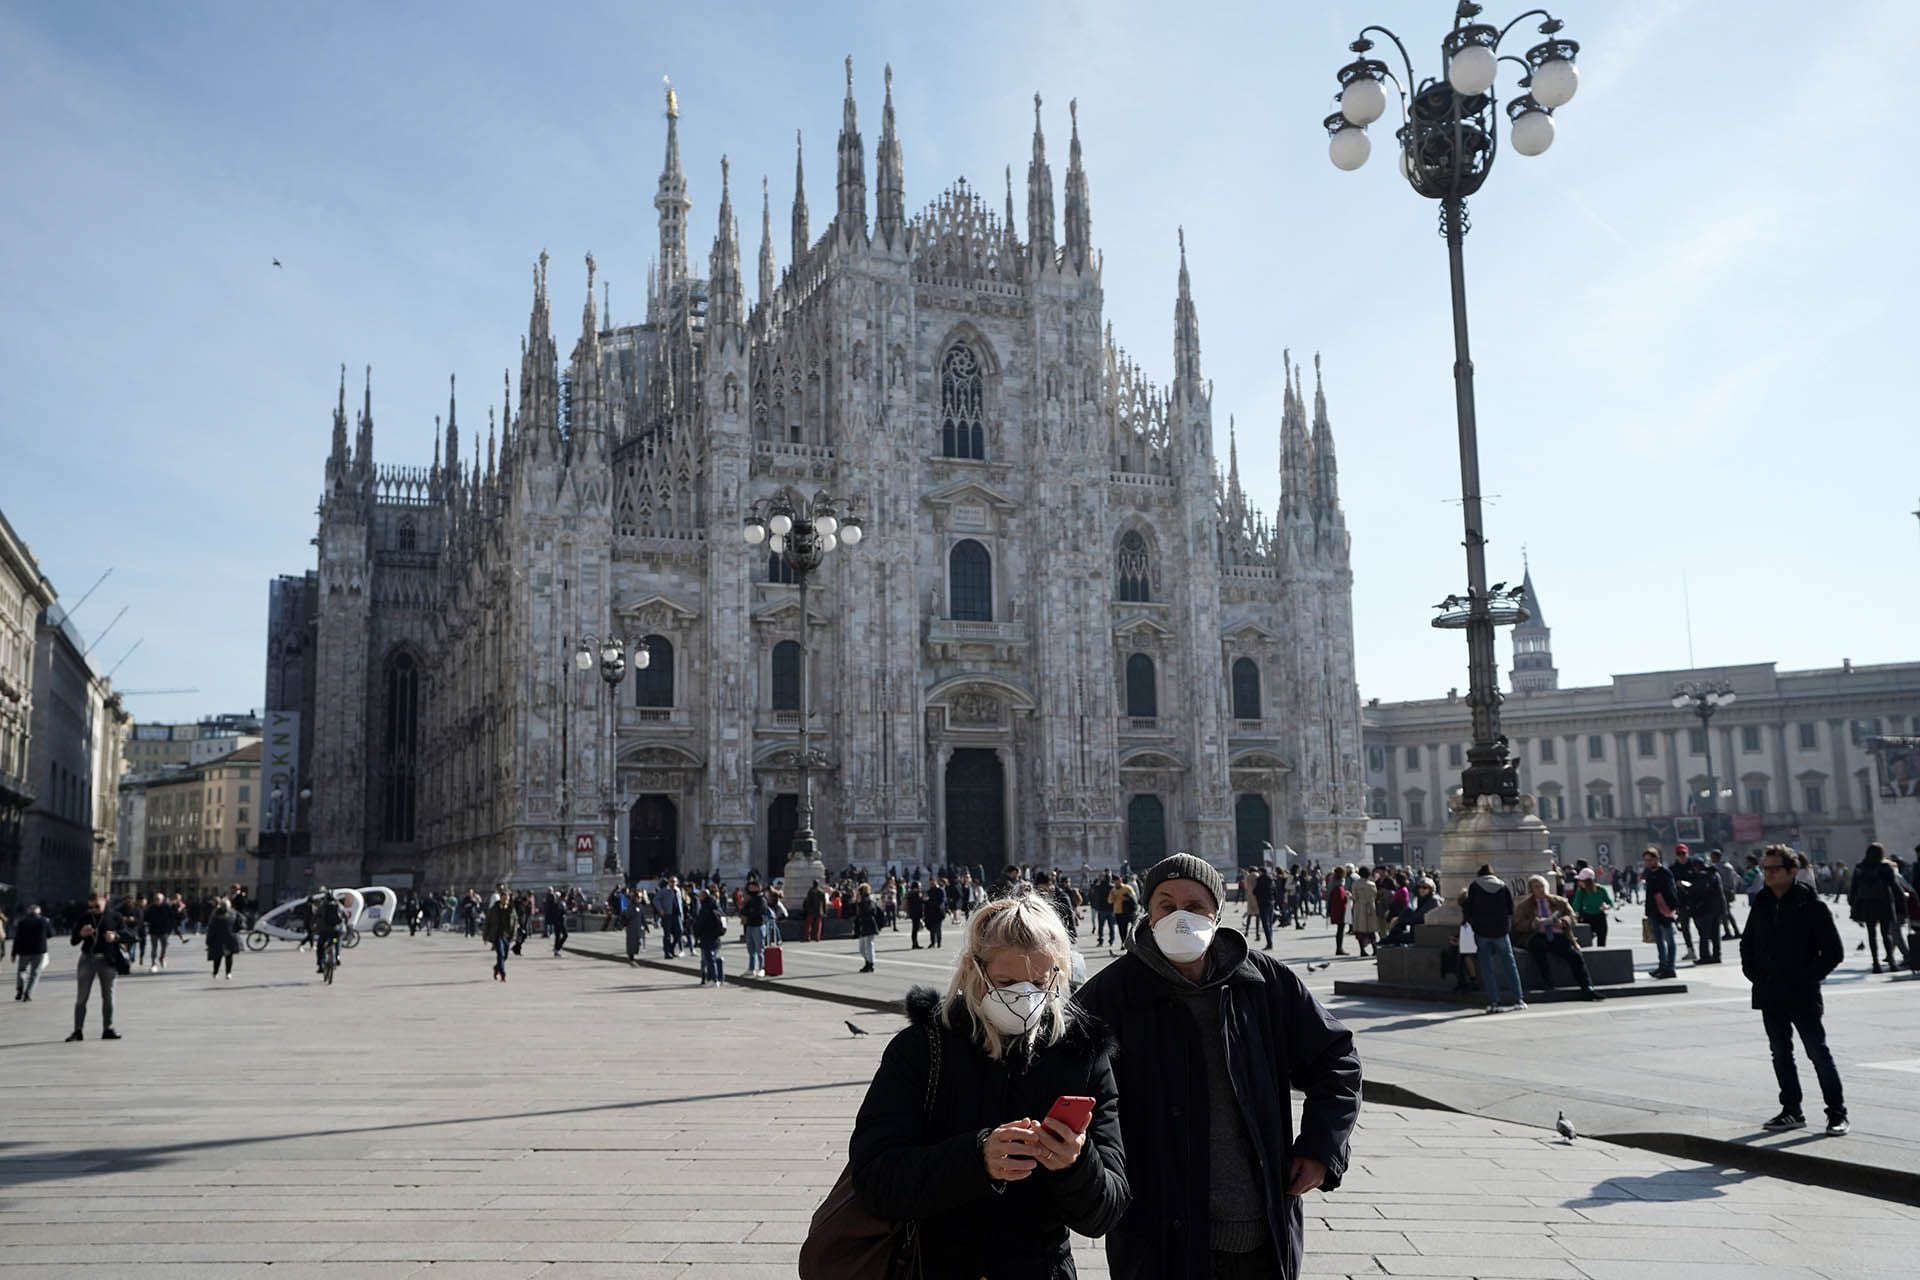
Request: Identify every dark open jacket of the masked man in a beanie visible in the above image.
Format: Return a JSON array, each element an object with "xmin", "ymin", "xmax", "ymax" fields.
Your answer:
[{"xmin": 1073, "ymin": 932, "xmax": 1359, "ymax": 1280}]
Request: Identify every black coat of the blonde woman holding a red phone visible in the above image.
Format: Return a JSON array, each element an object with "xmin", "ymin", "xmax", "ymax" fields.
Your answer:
[{"xmin": 849, "ymin": 986, "xmax": 1129, "ymax": 1280}]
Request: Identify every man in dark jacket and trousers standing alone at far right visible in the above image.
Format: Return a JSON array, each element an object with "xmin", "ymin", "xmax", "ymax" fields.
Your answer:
[{"xmin": 1740, "ymin": 844, "xmax": 1849, "ymax": 1138}]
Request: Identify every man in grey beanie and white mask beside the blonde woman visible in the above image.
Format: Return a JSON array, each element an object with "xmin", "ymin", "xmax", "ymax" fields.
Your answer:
[{"xmin": 1075, "ymin": 854, "xmax": 1359, "ymax": 1280}]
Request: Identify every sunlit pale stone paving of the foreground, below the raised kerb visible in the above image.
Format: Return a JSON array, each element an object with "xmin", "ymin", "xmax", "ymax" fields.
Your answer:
[{"xmin": 0, "ymin": 935, "xmax": 1920, "ymax": 1280}]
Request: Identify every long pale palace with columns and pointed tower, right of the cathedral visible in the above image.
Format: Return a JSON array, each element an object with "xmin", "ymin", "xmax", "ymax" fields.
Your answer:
[{"xmin": 1363, "ymin": 570, "xmax": 1920, "ymax": 865}]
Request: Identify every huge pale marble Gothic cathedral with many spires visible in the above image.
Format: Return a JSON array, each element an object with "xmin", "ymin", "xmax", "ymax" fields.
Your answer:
[{"xmin": 311, "ymin": 63, "xmax": 1365, "ymax": 889}]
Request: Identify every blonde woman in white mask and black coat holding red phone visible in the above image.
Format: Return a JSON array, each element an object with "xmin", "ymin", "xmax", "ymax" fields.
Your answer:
[{"xmin": 849, "ymin": 894, "xmax": 1131, "ymax": 1280}]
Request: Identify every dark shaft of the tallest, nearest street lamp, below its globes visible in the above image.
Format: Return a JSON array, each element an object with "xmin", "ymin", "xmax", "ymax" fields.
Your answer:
[{"xmin": 1440, "ymin": 196, "xmax": 1505, "ymax": 804}]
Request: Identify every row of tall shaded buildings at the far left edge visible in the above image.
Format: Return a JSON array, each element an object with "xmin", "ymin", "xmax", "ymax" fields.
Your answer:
[{"xmin": 0, "ymin": 514, "xmax": 129, "ymax": 906}]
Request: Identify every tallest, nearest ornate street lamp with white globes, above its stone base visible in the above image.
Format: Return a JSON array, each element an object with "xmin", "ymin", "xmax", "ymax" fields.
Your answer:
[{"xmin": 1325, "ymin": 0, "xmax": 1580, "ymax": 810}]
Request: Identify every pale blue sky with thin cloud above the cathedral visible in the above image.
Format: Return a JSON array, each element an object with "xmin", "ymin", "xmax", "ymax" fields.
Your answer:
[{"xmin": 0, "ymin": 0, "xmax": 1920, "ymax": 718}]
